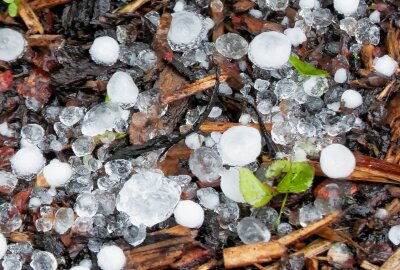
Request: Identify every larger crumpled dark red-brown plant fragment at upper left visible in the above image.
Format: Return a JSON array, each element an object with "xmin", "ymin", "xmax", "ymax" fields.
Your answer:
[{"xmin": 17, "ymin": 68, "xmax": 52, "ymax": 107}]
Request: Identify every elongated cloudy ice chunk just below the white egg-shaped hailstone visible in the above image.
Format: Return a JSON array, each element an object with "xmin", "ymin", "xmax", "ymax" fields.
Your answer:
[{"xmin": 82, "ymin": 102, "xmax": 123, "ymax": 136}]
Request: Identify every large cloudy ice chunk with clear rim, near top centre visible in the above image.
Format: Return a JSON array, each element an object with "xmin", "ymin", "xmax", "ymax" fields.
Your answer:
[{"xmin": 167, "ymin": 11, "xmax": 208, "ymax": 51}]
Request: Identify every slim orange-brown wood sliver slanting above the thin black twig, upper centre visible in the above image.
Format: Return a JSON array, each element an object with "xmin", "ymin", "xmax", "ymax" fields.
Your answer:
[{"xmin": 160, "ymin": 74, "xmax": 227, "ymax": 105}]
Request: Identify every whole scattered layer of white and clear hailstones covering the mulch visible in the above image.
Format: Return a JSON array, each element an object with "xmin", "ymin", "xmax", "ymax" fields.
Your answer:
[{"xmin": 0, "ymin": 0, "xmax": 400, "ymax": 270}]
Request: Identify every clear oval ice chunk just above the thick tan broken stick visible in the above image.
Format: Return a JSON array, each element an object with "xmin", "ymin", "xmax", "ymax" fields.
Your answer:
[{"xmin": 237, "ymin": 217, "xmax": 271, "ymax": 244}]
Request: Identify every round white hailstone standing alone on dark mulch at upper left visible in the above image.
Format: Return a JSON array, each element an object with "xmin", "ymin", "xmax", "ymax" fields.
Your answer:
[{"xmin": 89, "ymin": 36, "xmax": 119, "ymax": 66}]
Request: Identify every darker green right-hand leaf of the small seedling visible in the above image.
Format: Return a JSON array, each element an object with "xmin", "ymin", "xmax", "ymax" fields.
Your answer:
[{"xmin": 277, "ymin": 162, "xmax": 314, "ymax": 193}]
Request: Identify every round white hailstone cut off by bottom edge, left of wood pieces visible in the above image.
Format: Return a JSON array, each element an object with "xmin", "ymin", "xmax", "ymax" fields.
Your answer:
[{"xmin": 97, "ymin": 246, "xmax": 126, "ymax": 270}]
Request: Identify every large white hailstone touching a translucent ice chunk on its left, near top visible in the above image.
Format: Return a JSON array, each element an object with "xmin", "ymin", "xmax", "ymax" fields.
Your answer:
[{"xmin": 248, "ymin": 31, "xmax": 292, "ymax": 69}]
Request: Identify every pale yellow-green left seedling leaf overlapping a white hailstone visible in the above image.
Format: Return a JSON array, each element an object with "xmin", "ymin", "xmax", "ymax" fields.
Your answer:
[{"xmin": 239, "ymin": 168, "xmax": 275, "ymax": 207}]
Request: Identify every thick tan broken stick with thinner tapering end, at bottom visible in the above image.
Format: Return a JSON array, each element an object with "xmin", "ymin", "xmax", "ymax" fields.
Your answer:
[{"xmin": 223, "ymin": 211, "xmax": 342, "ymax": 268}]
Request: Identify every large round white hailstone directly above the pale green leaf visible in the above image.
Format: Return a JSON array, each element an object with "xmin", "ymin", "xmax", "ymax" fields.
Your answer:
[{"xmin": 218, "ymin": 126, "xmax": 261, "ymax": 166}]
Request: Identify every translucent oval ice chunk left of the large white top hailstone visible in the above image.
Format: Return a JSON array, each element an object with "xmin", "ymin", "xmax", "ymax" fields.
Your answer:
[{"xmin": 215, "ymin": 33, "xmax": 249, "ymax": 59}]
